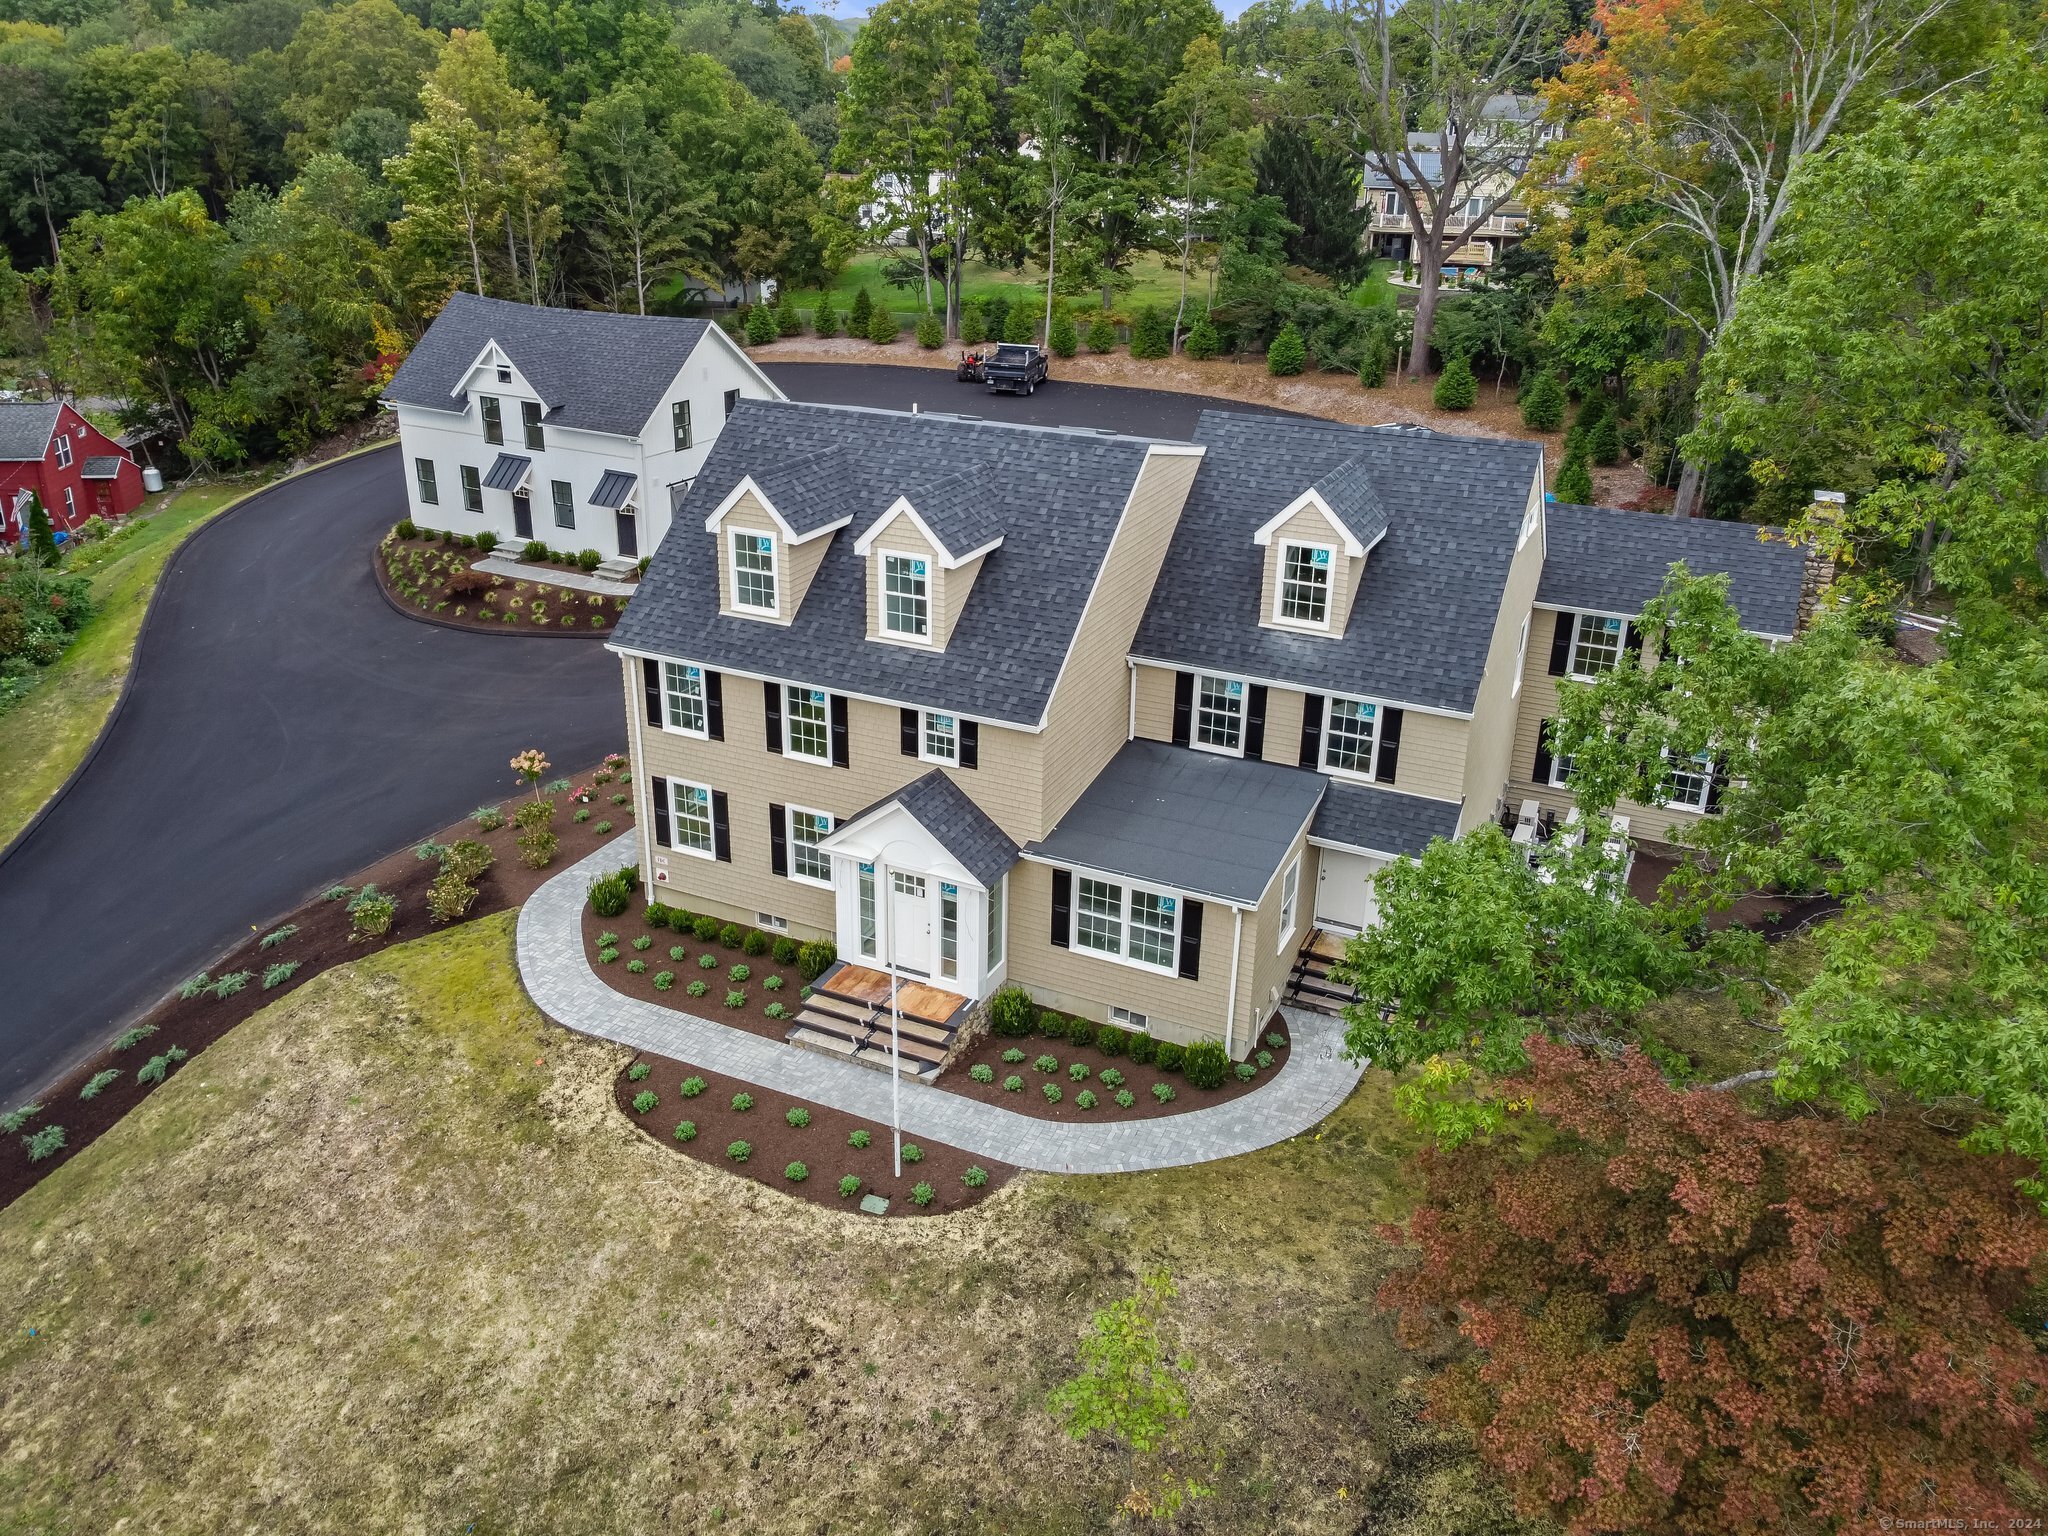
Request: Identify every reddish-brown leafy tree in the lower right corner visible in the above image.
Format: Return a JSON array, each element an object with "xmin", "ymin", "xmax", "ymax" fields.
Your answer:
[{"xmin": 1380, "ymin": 1036, "xmax": 2048, "ymax": 1536}]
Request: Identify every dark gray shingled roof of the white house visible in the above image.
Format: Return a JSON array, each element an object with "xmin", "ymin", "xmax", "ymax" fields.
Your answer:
[{"xmin": 383, "ymin": 293, "xmax": 711, "ymax": 436}]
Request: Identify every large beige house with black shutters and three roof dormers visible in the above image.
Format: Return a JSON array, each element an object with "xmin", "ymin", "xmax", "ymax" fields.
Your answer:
[{"xmin": 610, "ymin": 403, "xmax": 1802, "ymax": 1057}]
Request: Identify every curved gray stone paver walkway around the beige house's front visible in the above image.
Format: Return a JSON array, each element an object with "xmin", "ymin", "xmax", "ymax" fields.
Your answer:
[{"xmin": 518, "ymin": 834, "xmax": 1362, "ymax": 1174}]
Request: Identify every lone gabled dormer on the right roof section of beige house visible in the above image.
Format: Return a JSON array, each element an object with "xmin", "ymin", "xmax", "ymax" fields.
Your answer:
[{"xmin": 1251, "ymin": 459, "xmax": 1386, "ymax": 639}]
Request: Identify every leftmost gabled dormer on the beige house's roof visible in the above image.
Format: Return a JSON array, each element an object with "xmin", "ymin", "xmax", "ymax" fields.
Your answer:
[{"xmin": 705, "ymin": 449, "xmax": 854, "ymax": 625}]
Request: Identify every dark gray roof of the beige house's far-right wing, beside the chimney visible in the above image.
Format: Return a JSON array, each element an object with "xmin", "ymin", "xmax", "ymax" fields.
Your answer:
[{"xmin": 1536, "ymin": 504, "xmax": 1806, "ymax": 635}]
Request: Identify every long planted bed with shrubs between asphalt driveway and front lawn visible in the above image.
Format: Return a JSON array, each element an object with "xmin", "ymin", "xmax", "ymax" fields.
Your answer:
[{"xmin": 0, "ymin": 752, "xmax": 633, "ymax": 1206}]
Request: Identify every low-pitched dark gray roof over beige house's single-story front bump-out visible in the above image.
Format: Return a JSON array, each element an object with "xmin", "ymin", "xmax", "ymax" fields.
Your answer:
[{"xmin": 1026, "ymin": 741, "xmax": 1329, "ymax": 907}]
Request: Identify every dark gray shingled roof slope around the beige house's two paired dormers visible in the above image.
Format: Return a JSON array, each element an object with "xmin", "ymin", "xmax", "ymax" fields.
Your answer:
[{"xmin": 612, "ymin": 399, "xmax": 1151, "ymax": 725}]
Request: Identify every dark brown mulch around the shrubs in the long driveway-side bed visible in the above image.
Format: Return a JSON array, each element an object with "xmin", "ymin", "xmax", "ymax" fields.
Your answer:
[{"xmin": 0, "ymin": 772, "xmax": 633, "ymax": 1206}]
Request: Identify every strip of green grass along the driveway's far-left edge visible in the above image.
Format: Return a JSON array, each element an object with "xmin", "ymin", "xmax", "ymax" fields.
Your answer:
[{"xmin": 0, "ymin": 479, "xmax": 260, "ymax": 846}]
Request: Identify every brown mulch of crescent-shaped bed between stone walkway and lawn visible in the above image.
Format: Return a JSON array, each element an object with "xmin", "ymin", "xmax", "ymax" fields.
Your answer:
[{"xmin": 612, "ymin": 1055, "xmax": 1016, "ymax": 1217}]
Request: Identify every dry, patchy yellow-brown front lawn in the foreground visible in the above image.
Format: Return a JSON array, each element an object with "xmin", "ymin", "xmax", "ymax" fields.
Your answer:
[{"xmin": 0, "ymin": 913, "xmax": 1540, "ymax": 1536}]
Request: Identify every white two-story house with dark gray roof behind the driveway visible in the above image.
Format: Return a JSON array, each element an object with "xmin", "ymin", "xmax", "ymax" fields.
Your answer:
[{"xmin": 383, "ymin": 293, "xmax": 782, "ymax": 561}]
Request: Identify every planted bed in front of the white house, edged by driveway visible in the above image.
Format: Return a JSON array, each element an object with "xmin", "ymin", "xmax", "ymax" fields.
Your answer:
[{"xmin": 371, "ymin": 522, "xmax": 627, "ymax": 635}]
